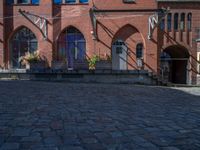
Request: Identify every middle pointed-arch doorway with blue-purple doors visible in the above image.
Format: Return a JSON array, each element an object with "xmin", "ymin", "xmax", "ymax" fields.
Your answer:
[{"xmin": 57, "ymin": 26, "xmax": 86, "ymax": 68}]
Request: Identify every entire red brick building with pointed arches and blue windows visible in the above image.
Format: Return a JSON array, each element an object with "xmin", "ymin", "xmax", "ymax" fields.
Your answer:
[{"xmin": 0, "ymin": 0, "xmax": 200, "ymax": 84}]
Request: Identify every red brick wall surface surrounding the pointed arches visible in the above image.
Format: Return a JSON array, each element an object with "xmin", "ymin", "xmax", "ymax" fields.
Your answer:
[{"xmin": 0, "ymin": 0, "xmax": 200, "ymax": 83}]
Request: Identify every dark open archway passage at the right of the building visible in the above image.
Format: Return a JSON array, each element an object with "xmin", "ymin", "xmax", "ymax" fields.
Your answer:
[{"xmin": 161, "ymin": 46, "xmax": 189, "ymax": 84}]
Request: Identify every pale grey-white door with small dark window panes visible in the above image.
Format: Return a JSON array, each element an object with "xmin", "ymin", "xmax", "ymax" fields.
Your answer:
[{"xmin": 112, "ymin": 40, "xmax": 127, "ymax": 70}]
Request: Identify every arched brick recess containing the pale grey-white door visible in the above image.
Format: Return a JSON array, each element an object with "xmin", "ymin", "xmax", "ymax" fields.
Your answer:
[{"xmin": 112, "ymin": 24, "xmax": 145, "ymax": 70}]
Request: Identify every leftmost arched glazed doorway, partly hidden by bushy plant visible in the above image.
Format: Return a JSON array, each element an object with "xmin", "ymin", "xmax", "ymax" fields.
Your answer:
[{"xmin": 10, "ymin": 27, "xmax": 38, "ymax": 69}]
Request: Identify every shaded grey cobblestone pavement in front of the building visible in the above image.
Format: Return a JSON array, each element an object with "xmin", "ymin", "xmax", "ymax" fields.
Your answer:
[{"xmin": 0, "ymin": 81, "xmax": 200, "ymax": 150}]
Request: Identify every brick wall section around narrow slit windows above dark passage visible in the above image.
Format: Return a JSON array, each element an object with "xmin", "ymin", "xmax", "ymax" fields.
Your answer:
[{"xmin": 158, "ymin": 2, "xmax": 200, "ymax": 83}]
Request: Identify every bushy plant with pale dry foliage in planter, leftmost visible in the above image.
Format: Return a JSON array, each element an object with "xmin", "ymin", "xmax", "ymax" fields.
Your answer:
[{"xmin": 21, "ymin": 51, "xmax": 46, "ymax": 71}]
